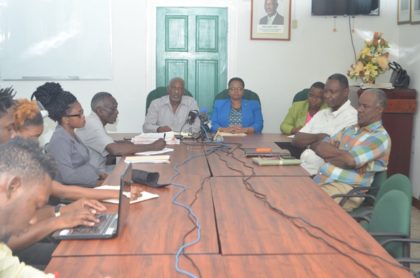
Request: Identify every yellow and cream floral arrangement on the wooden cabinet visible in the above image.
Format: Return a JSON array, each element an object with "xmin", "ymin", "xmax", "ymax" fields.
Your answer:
[{"xmin": 347, "ymin": 32, "xmax": 389, "ymax": 83}]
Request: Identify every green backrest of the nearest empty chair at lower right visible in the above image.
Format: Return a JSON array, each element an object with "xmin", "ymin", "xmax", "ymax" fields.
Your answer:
[{"xmin": 367, "ymin": 189, "xmax": 412, "ymax": 258}]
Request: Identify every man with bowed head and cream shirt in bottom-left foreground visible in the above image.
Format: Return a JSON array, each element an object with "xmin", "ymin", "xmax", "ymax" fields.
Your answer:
[{"xmin": 0, "ymin": 138, "xmax": 55, "ymax": 277}]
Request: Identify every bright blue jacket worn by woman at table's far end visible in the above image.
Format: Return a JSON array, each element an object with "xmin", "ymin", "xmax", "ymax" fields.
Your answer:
[{"xmin": 211, "ymin": 98, "xmax": 263, "ymax": 133}]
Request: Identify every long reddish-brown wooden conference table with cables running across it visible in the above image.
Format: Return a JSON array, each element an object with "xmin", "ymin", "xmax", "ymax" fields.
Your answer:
[{"xmin": 46, "ymin": 134, "xmax": 410, "ymax": 277}]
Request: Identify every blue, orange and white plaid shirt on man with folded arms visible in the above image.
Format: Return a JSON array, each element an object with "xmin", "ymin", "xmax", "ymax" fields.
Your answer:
[{"xmin": 314, "ymin": 121, "xmax": 391, "ymax": 186}]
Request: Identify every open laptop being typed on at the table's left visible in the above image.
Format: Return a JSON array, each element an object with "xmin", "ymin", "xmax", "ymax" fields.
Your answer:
[{"xmin": 52, "ymin": 163, "xmax": 132, "ymax": 239}]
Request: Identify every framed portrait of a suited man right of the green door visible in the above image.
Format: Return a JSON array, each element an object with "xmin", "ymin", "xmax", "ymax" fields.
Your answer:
[{"xmin": 251, "ymin": 0, "xmax": 291, "ymax": 41}]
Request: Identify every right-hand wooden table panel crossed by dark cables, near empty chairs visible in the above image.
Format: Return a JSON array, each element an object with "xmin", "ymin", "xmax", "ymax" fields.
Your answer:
[{"xmin": 211, "ymin": 177, "xmax": 398, "ymax": 255}]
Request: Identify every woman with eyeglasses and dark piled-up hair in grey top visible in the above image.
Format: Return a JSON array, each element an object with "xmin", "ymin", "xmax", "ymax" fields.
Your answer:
[{"xmin": 31, "ymin": 82, "xmax": 107, "ymax": 187}]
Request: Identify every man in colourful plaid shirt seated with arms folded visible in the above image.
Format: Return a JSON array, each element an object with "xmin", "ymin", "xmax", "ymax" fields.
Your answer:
[{"xmin": 311, "ymin": 89, "xmax": 391, "ymax": 210}]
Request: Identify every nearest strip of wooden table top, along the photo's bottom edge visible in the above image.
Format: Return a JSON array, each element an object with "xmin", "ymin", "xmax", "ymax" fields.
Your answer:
[{"xmin": 46, "ymin": 254, "xmax": 412, "ymax": 278}]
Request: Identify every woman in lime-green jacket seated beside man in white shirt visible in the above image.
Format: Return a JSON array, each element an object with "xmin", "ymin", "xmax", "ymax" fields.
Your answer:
[{"xmin": 280, "ymin": 82, "xmax": 327, "ymax": 135}]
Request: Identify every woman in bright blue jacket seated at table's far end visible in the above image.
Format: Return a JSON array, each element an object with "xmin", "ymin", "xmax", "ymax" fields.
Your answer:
[{"xmin": 211, "ymin": 77, "xmax": 263, "ymax": 134}]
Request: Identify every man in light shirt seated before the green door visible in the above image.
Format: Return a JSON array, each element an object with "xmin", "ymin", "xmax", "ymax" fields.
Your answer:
[{"xmin": 143, "ymin": 77, "xmax": 200, "ymax": 133}]
